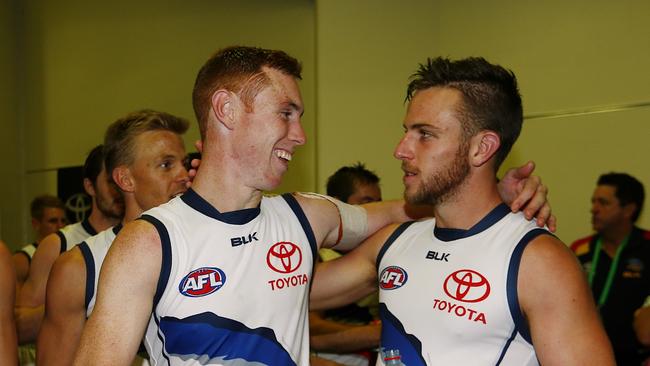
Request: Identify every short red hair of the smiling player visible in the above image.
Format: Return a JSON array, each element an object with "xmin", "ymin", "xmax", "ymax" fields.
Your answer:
[{"xmin": 192, "ymin": 46, "xmax": 302, "ymax": 138}]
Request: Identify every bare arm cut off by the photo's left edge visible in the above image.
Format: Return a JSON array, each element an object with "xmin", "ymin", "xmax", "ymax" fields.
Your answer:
[{"xmin": 0, "ymin": 241, "xmax": 18, "ymax": 365}]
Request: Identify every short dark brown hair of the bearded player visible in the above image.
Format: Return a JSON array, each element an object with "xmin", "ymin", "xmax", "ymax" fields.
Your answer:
[{"xmin": 406, "ymin": 57, "xmax": 523, "ymax": 170}]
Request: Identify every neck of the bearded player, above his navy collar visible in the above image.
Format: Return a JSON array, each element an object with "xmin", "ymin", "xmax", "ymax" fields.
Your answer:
[{"xmin": 434, "ymin": 171, "xmax": 502, "ymax": 230}]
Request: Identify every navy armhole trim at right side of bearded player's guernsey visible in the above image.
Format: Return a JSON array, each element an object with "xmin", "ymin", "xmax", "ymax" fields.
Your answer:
[{"xmin": 504, "ymin": 229, "xmax": 550, "ymax": 344}]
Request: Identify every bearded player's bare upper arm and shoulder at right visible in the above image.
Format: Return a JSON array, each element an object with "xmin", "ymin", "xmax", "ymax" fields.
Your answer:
[{"xmin": 517, "ymin": 235, "xmax": 615, "ymax": 365}]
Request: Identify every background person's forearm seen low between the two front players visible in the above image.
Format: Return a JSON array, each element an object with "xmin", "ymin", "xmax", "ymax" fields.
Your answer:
[{"xmin": 310, "ymin": 324, "xmax": 381, "ymax": 353}]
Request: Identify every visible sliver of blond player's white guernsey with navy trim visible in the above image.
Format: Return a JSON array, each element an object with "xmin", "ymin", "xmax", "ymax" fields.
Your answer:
[{"xmin": 79, "ymin": 224, "xmax": 122, "ymax": 318}]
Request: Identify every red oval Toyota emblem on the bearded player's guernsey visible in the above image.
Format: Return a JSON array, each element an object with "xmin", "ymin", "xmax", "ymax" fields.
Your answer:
[{"xmin": 444, "ymin": 269, "xmax": 490, "ymax": 302}]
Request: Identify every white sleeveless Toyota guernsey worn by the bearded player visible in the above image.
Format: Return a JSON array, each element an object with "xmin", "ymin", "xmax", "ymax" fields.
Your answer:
[{"xmin": 377, "ymin": 204, "xmax": 549, "ymax": 366}]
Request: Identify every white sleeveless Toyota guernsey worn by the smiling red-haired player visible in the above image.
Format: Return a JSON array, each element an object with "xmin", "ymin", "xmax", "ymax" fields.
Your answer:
[{"xmin": 141, "ymin": 189, "xmax": 316, "ymax": 366}]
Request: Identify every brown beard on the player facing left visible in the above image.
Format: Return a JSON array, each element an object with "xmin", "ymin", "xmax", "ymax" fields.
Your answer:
[{"xmin": 404, "ymin": 143, "xmax": 470, "ymax": 206}]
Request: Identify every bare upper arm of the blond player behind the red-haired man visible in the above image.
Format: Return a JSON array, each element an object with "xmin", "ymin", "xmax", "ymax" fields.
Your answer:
[{"xmin": 36, "ymin": 247, "xmax": 86, "ymax": 365}]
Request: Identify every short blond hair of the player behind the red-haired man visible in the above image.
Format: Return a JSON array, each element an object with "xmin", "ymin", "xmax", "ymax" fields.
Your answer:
[{"xmin": 104, "ymin": 109, "xmax": 189, "ymax": 181}]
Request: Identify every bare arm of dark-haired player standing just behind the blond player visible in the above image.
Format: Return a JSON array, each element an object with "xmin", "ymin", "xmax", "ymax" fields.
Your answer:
[{"xmin": 16, "ymin": 234, "xmax": 61, "ymax": 344}]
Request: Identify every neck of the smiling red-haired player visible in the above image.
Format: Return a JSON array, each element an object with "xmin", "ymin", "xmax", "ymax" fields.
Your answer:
[{"xmin": 192, "ymin": 138, "xmax": 263, "ymax": 212}]
